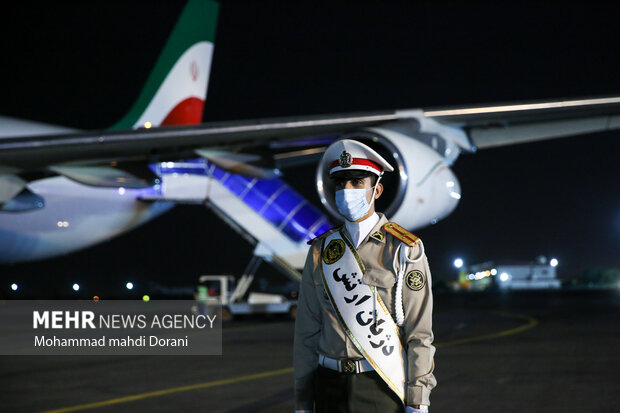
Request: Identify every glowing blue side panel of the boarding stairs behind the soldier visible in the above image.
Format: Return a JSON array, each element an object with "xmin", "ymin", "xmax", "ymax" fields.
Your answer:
[{"xmin": 160, "ymin": 159, "xmax": 332, "ymax": 242}]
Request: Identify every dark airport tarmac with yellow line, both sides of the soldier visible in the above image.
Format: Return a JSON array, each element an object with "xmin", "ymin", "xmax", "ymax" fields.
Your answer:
[{"xmin": 0, "ymin": 290, "xmax": 620, "ymax": 413}]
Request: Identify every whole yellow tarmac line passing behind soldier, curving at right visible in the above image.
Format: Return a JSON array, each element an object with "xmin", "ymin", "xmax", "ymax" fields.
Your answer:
[{"xmin": 42, "ymin": 312, "xmax": 538, "ymax": 413}]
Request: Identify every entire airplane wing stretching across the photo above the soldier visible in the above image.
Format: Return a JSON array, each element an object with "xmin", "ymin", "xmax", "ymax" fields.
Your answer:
[{"xmin": 0, "ymin": 97, "xmax": 620, "ymax": 173}]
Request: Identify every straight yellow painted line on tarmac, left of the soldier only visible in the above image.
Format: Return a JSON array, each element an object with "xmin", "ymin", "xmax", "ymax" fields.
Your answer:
[{"xmin": 43, "ymin": 367, "xmax": 293, "ymax": 413}]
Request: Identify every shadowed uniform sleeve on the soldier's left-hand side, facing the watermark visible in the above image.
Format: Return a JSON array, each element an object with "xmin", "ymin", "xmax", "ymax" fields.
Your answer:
[{"xmin": 293, "ymin": 246, "xmax": 321, "ymax": 411}]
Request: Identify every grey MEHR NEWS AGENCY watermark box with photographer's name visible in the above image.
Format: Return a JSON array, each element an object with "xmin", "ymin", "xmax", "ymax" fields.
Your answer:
[{"xmin": 0, "ymin": 300, "xmax": 222, "ymax": 355}]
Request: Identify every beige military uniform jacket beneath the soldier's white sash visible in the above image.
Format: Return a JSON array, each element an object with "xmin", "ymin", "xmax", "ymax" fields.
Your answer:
[{"xmin": 294, "ymin": 213, "xmax": 436, "ymax": 410}]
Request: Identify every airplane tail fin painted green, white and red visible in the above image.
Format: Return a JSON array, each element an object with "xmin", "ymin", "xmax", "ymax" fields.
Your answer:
[{"xmin": 111, "ymin": 0, "xmax": 219, "ymax": 129}]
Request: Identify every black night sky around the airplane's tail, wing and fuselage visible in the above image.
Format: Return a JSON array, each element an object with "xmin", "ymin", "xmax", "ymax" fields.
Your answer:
[{"xmin": 0, "ymin": 1, "xmax": 620, "ymax": 296}]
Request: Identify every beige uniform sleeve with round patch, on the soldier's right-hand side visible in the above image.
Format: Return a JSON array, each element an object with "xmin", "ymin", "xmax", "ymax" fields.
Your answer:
[{"xmin": 403, "ymin": 243, "xmax": 437, "ymax": 406}]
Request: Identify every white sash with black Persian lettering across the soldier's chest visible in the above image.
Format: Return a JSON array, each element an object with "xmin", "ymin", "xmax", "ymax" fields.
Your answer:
[{"xmin": 321, "ymin": 227, "xmax": 407, "ymax": 403}]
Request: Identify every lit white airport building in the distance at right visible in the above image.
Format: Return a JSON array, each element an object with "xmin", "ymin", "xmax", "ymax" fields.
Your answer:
[{"xmin": 458, "ymin": 257, "xmax": 561, "ymax": 291}]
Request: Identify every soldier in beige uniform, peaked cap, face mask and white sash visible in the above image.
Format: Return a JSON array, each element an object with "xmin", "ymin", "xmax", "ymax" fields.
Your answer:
[{"xmin": 294, "ymin": 139, "xmax": 436, "ymax": 413}]
